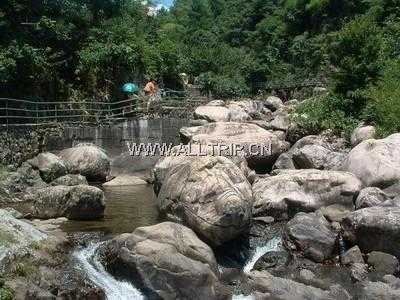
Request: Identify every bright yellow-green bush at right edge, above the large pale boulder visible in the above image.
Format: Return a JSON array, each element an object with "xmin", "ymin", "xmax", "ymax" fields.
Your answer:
[{"xmin": 362, "ymin": 60, "xmax": 400, "ymax": 137}]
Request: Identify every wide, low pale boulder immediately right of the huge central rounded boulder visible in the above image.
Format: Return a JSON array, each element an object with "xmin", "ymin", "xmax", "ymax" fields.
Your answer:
[{"xmin": 253, "ymin": 169, "xmax": 361, "ymax": 219}]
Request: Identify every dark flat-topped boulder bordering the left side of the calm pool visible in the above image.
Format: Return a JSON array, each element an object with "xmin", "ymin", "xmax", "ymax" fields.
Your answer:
[{"xmin": 26, "ymin": 185, "xmax": 105, "ymax": 220}]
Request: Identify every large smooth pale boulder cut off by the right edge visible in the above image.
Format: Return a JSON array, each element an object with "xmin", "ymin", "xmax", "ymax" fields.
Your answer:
[{"xmin": 342, "ymin": 133, "xmax": 400, "ymax": 188}]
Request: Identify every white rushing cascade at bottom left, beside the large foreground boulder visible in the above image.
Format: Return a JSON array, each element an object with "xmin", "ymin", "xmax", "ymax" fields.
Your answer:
[{"xmin": 74, "ymin": 243, "xmax": 145, "ymax": 300}]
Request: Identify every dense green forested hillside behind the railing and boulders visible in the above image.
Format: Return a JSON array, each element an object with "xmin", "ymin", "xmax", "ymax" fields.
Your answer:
[{"xmin": 0, "ymin": 0, "xmax": 400, "ymax": 133}]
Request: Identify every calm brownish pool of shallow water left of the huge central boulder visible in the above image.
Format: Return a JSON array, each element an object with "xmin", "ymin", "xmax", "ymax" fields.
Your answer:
[{"xmin": 63, "ymin": 185, "xmax": 160, "ymax": 235}]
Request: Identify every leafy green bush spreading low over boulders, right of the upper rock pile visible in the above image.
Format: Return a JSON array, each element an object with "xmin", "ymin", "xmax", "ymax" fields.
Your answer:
[{"xmin": 293, "ymin": 95, "xmax": 358, "ymax": 138}]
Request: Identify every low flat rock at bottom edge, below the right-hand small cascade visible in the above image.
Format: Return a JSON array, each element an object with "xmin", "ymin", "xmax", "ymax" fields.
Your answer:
[{"xmin": 247, "ymin": 271, "xmax": 351, "ymax": 300}]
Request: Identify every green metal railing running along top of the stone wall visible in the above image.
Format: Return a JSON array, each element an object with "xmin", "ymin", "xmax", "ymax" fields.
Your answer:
[{"xmin": 0, "ymin": 90, "xmax": 211, "ymax": 126}]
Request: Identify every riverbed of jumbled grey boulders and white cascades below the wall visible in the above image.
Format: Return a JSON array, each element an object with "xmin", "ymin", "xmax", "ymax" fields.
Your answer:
[{"xmin": 0, "ymin": 97, "xmax": 400, "ymax": 300}]
